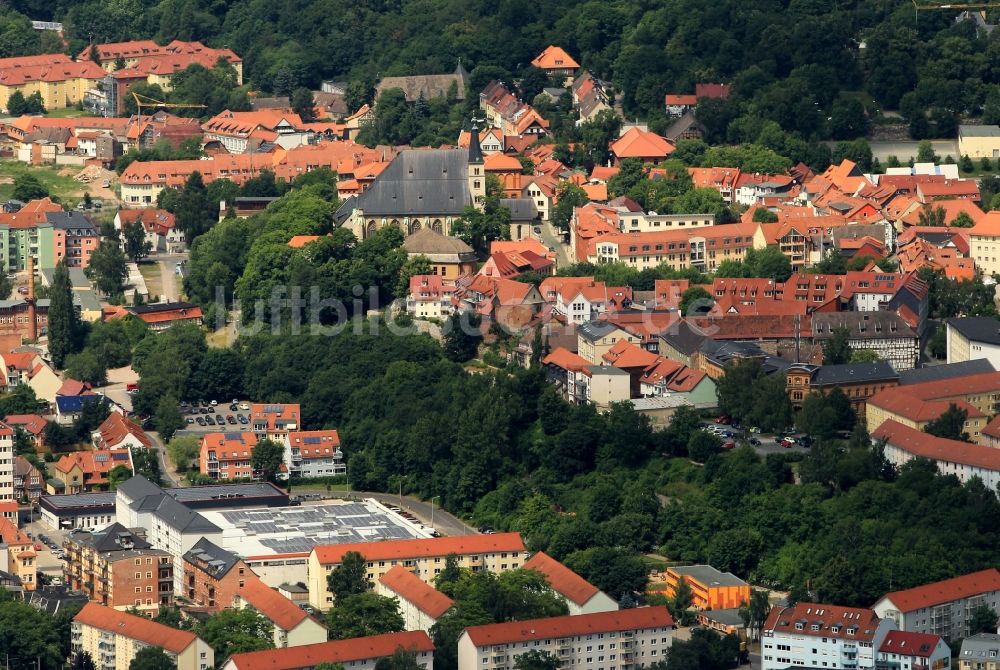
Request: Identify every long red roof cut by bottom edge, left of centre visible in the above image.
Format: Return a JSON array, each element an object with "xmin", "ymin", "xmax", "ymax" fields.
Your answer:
[{"xmin": 229, "ymin": 630, "xmax": 434, "ymax": 670}]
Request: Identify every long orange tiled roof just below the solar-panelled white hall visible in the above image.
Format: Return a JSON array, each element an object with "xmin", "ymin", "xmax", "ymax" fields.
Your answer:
[{"xmin": 313, "ymin": 533, "xmax": 524, "ymax": 565}]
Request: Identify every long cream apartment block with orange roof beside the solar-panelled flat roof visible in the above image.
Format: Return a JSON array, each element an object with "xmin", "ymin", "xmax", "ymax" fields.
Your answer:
[{"xmin": 309, "ymin": 533, "xmax": 528, "ymax": 610}]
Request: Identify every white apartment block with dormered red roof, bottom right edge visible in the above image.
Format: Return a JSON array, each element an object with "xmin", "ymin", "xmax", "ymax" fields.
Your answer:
[{"xmin": 761, "ymin": 603, "xmax": 896, "ymax": 670}]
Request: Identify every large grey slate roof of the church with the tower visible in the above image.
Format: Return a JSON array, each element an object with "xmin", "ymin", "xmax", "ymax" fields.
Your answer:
[{"xmin": 337, "ymin": 149, "xmax": 472, "ymax": 218}]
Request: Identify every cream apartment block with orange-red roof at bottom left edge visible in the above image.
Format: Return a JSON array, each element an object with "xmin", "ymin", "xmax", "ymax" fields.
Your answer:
[{"xmin": 70, "ymin": 603, "xmax": 215, "ymax": 670}]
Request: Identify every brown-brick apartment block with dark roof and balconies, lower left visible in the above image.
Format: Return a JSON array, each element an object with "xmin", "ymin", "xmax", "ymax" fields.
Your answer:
[{"xmin": 63, "ymin": 523, "xmax": 174, "ymax": 613}]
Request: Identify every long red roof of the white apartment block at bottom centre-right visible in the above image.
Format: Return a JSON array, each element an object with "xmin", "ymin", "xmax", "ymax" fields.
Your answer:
[{"xmin": 465, "ymin": 607, "xmax": 674, "ymax": 647}]
